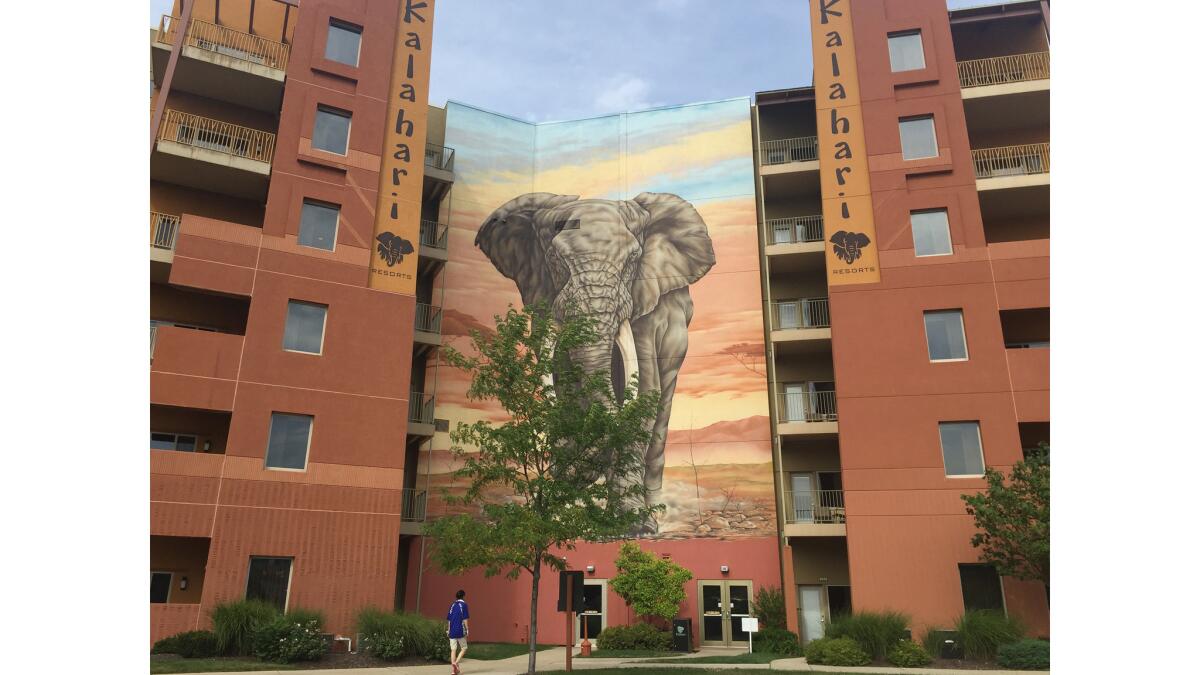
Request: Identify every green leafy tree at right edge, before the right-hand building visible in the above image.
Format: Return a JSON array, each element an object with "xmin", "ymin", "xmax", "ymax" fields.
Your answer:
[{"xmin": 962, "ymin": 443, "xmax": 1050, "ymax": 599}]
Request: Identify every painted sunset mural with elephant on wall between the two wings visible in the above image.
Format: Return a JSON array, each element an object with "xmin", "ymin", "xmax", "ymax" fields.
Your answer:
[{"xmin": 420, "ymin": 98, "xmax": 775, "ymax": 539}]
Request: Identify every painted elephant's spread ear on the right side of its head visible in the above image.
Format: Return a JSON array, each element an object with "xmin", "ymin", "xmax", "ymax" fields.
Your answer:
[{"xmin": 630, "ymin": 192, "xmax": 716, "ymax": 318}]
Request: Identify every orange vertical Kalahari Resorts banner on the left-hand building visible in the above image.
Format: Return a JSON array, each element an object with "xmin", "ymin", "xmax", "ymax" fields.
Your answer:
[{"xmin": 368, "ymin": 0, "xmax": 434, "ymax": 295}]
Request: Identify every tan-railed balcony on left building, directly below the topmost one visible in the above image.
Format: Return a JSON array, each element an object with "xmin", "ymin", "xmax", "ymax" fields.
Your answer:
[{"xmin": 150, "ymin": 109, "xmax": 275, "ymax": 201}]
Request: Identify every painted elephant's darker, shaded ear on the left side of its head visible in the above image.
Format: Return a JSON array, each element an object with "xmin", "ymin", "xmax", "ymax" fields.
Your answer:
[{"xmin": 475, "ymin": 192, "xmax": 578, "ymax": 305}]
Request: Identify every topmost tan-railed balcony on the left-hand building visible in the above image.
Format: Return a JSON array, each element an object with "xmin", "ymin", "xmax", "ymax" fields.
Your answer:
[{"xmin": 150, "ymin": 16, "xmax": 290, "ymax": 113}]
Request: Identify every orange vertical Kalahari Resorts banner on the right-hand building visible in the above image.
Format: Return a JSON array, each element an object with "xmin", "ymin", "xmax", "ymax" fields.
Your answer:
[{"xmin": 809, "ymin": 0, "xmax": 880, "ymax": 286}]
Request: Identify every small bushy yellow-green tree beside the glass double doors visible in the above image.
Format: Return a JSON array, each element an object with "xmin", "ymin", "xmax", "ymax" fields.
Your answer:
[{"xmin": 612, "ymin": 542, "xmax": 691, "ymax": 621}]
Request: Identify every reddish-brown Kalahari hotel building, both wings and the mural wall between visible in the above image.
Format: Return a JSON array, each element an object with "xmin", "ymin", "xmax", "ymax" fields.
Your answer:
[{"xmin": 150, "ymin": 0, "xmax": 1050, "ymax": 645}]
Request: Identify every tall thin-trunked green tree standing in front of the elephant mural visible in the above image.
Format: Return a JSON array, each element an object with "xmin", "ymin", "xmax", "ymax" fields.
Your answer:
[{"xmin": 426, "ymin": 305, "xmax": 662, "ymax": 673}]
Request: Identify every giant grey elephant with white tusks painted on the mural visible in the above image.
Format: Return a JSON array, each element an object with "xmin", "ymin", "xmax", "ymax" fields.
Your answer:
[{"xmin": 475, "ymin": 192, "xmax": 716, "ymax": 534}]
